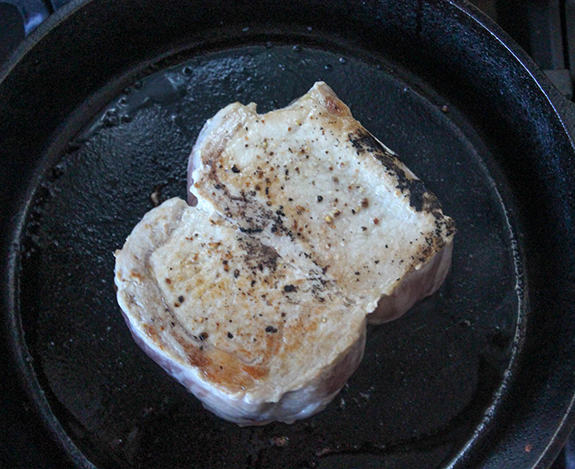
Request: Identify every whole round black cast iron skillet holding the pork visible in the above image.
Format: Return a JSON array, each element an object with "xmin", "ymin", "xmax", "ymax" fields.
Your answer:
[{"xmin": 0, "ymin": 0, "xmax": 575, "ymax": 468}]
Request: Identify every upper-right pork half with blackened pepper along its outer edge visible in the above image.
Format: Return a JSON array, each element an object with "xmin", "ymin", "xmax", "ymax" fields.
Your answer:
[{"xmin": 189, "ymin": 82, "xmax": 455, "ymax": 323}]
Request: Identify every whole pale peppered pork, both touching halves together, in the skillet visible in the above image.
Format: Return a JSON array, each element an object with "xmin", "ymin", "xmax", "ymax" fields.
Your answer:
[{"xmin": 115, "ymin": 83, "xmax": 455, "ymax": 425}]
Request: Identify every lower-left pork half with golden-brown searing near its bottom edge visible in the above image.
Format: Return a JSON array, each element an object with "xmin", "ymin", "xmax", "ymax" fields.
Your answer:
[{"xmin": 115, "ymin": 198, "xmax": 366, "ymax": 425}]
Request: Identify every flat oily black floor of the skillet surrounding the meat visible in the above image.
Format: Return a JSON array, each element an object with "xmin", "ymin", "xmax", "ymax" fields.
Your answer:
[{"xmin": 20, "ymin": 44, "xmax": 521, "ymax": 469}]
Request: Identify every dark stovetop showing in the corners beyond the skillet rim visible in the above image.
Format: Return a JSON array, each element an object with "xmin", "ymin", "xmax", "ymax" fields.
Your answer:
[{"xmin": 0, "ymin": 0, "xmax": 575, "ymax": 469}]
